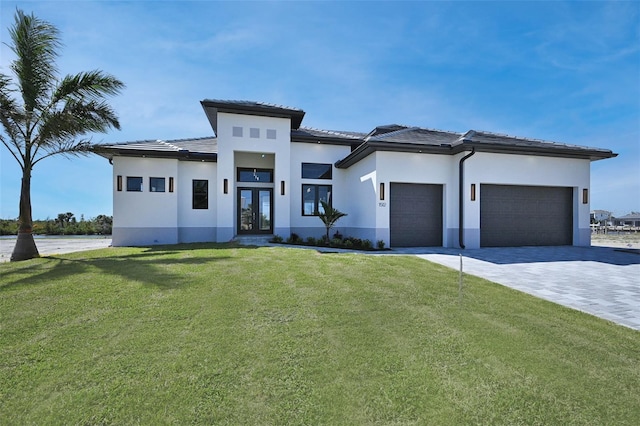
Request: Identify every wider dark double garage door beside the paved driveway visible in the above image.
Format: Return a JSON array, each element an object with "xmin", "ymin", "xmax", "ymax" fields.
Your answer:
[{"xmin": 480, "ymin": 185, "xmax": 573, "ymax": 247}]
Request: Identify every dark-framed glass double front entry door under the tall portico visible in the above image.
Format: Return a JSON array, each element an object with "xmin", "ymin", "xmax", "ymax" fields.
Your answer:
[{"xmin": 238, "ymin": 188, "xmax": 273, "ymax": 234}]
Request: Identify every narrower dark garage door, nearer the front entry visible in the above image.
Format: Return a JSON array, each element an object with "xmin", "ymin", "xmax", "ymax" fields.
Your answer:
[{"xmin": 389, "ymin": 183, "xmax": 442, "ymax": 247}]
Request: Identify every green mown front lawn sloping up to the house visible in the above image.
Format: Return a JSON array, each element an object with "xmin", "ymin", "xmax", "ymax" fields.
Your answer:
[{"xmin": 0, "ymin": 245, "xmax": 640, "ymax": 425}]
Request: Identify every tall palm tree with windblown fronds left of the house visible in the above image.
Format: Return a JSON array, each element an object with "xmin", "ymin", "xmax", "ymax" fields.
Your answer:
[{"xmin": 0, "ymin": 10, "xmax": 124, "ymax": 261}]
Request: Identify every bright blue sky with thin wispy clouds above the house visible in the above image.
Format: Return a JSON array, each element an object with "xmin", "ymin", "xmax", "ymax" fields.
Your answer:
[{"xmin": 0, "ymin": 0, "xmax": 640, "ymax": 219}]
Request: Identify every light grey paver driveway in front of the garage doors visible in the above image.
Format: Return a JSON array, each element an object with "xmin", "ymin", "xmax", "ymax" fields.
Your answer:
[{"xmin": 396, "ymin": 247, "xmax": 640, "ymax": 330}]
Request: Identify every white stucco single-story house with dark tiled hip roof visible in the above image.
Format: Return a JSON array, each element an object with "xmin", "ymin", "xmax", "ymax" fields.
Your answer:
[{"xmin": 96, "ymin": 99, "xmax": 617, "ymax": 248}]
